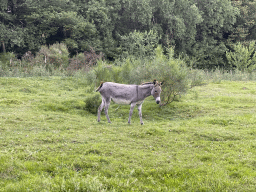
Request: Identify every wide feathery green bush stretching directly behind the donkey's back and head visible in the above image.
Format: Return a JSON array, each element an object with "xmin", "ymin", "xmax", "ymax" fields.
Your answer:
[{"xmin": 85, "ymin": 47, "xmax": 188, "ymax": 105}]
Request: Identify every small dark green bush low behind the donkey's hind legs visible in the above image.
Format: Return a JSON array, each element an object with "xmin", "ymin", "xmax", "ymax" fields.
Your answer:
[{"xmin": 85, "ymin": 93, "xmax": 101, "ymax": 114}]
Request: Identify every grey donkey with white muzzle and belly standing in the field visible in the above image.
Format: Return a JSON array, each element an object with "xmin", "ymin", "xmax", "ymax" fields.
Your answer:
[{"xmin": 96, "ymin": 80, "xmax": 163, "ymax": 125}]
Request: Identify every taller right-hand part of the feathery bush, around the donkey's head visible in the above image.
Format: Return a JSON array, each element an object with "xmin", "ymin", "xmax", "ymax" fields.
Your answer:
[{"xmin": 131, "ymin": 46, "xmax": 188, "ymax": 105}]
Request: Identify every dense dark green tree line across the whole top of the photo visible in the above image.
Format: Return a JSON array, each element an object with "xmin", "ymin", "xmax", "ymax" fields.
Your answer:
[{"xmin": 0, "ymin": 0, "xmax": 256, "ymax": 69}]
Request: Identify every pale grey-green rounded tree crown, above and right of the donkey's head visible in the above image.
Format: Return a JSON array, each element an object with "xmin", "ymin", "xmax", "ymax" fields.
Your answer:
[{"xmin": 151, "ymin": 0, "xmax": 203, "ymax": 53}]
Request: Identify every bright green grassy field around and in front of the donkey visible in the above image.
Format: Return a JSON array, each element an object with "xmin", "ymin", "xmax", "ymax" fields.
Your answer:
[{"xmin": 0, "ymin": 77, "xmax": 256, "ymax": 192}]
